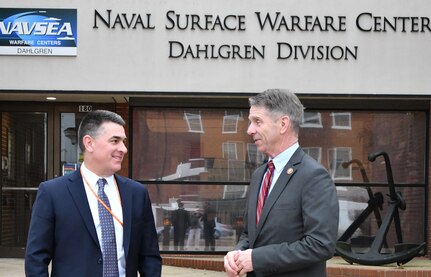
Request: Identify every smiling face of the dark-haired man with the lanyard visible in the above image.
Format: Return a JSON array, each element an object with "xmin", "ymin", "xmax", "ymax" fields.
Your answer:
[{"xmin": 92, "ymin": 122, "xmax": 127, "ymax": 176}]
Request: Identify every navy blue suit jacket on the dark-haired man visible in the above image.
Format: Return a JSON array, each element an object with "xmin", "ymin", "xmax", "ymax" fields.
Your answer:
[{"xmin": 25, "ymin": 170, "xmax": 161, "ymax": 277}]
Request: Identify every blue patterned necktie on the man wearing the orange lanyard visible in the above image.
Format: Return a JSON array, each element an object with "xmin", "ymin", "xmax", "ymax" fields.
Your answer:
[{"xmin": 97, "ymin": 178, "xmax": 118, "ymax": 277}]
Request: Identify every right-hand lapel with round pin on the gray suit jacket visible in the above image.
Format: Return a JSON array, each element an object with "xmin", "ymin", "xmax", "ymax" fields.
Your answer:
[{"xmin": 255, "ymin": 148, "xmax": 305, "ymax": 234}]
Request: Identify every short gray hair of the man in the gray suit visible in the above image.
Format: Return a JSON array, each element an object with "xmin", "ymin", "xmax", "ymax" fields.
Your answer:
[{"xmin": 248, "ymin": 89, "xmax": 304, "ymax": 133}]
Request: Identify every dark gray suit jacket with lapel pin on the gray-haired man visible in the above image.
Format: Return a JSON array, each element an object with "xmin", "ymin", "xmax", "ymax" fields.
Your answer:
[{"xmin": 236, "ymin": 148, "xmax": 339, "ymax": 277}]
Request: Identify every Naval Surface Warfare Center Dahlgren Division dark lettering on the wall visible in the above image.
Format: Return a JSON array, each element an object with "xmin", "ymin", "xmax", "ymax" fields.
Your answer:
[{"xmin": 93, "ymin": 9, "xmax": 431, "ymax": 63}]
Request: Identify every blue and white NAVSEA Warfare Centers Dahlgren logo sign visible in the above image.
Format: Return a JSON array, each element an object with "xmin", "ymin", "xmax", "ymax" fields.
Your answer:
[{"xmin": 0, "ymin": 8, "xmax": 78, "ymax": 56}]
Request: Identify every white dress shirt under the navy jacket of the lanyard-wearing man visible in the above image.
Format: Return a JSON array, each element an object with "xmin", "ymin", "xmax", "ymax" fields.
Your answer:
[{"xmin": 81, "ymin": 163, "xmax": 126, "ymax": 277}]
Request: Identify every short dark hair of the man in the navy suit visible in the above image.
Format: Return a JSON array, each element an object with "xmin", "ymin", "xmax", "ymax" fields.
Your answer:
[{"xmin": 78, "ymin": 110, "xmax": 126, "ymax": 152}]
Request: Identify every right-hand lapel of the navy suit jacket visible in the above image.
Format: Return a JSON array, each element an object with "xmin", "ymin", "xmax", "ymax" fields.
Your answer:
[{"xmin": 114, "ymin": 175, "xmax": 133, "ymax": 258}]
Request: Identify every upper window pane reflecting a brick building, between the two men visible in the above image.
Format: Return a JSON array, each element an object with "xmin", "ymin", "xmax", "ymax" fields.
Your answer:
[{"xmin": 132, "ymin": 108, "xmax": 258, "ymax": 181}]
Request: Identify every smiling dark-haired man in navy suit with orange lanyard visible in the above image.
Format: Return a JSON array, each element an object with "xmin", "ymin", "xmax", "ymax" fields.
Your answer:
[{"xmin": 25, "ymin": 110, "xmax": 161, "ymax": 277}]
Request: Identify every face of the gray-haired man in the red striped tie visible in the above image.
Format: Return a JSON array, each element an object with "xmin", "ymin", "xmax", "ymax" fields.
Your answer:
[{"xmin": 247, "ymin": 106, "xmax": 280, "ymax": 157}]
